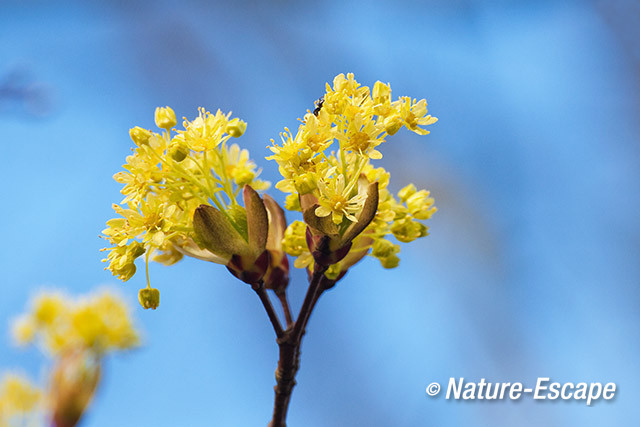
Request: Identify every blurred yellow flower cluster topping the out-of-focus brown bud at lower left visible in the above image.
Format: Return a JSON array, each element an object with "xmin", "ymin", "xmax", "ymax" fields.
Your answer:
[{"xmin": 13, "ymin": 291, "xmax": 139, "ymax": 356}]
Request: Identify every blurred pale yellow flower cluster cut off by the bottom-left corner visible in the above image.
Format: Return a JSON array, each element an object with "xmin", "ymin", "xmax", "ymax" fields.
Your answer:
[{"xmin": 0, "ymin": 374, "xmax": 42, "ymax": 427}]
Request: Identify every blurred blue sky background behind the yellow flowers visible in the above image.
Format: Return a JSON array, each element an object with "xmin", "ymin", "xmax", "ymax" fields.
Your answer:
[{"xmin": 0, "ymin": 0, "xmax": 640, "ymax": 427}]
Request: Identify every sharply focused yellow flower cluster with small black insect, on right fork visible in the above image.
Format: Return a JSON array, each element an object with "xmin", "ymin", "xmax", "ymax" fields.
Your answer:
[{"xmin": 267, "ymin": 74, "xmax": 437, "ymax": 278}]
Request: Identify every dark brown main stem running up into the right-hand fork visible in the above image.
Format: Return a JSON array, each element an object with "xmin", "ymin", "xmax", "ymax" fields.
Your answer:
[{"xmin": 269, "ymin": 264, "xmax": 327, "ymax": 427}]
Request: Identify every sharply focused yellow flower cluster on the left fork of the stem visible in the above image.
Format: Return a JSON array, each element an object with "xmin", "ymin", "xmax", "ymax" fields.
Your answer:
[{"xmin": 103, "ymin": 107, "xmax": 269, "ymax": 288}]
